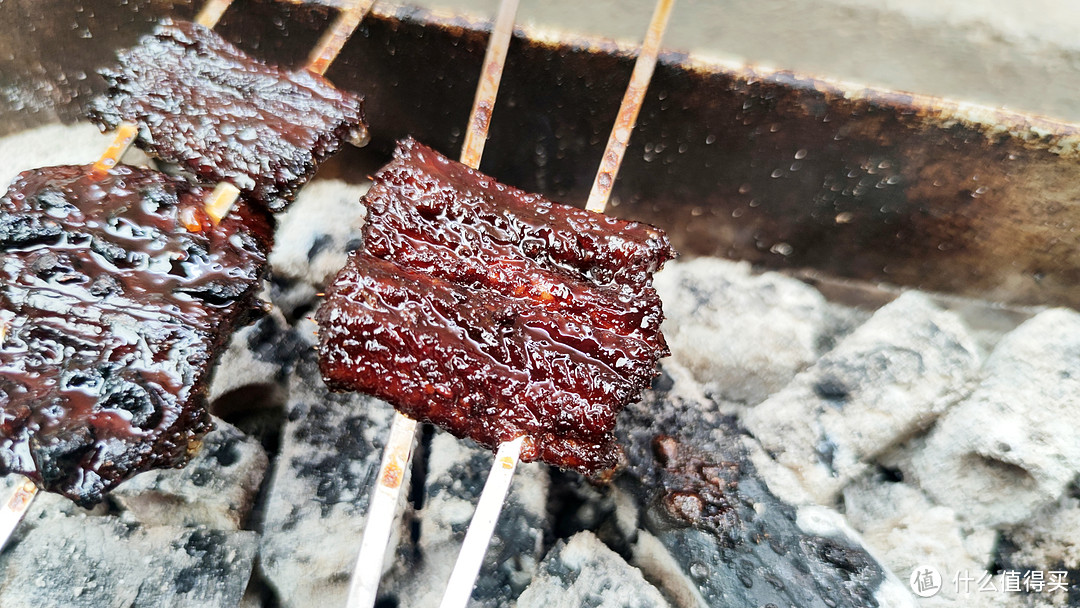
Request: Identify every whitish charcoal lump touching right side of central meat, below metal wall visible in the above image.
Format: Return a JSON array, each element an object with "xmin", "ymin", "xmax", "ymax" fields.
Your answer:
[{"xmin": 654, "ymin": 258, "xmax": 850, "ymax": 404}]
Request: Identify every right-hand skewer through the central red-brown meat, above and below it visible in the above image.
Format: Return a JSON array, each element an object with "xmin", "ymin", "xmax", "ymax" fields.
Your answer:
[{"xmin": 440, "ymin": 0, "xmax": 674, "ymax": 608}]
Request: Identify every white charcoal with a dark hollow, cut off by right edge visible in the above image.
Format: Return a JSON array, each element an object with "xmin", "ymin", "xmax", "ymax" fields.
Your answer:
[{"xmin": 912, "ymin": 309, "xmax": 1080, "ymax": 526}]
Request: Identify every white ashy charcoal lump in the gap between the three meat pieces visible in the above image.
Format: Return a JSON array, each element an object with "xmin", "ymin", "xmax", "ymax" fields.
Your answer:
[{"xmin": 270, "ymin": 179, "xmax": 369, "ymax": 319}]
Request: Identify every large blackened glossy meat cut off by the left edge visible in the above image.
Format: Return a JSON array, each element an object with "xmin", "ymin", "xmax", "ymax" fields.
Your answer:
[{"xmin": 0, "ymin": 166, "xmax": 272, "ymax": 505}]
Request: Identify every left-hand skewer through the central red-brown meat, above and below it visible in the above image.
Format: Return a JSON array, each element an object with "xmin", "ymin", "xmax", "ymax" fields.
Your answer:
[{"xmin": 348, "ymin": 0, "xmax": 518, "ymax": 608}]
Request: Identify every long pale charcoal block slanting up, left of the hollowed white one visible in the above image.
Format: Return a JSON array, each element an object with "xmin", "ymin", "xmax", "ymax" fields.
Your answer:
[{"xmin": 742, "ymin": 292, "xmax": 980, "ymax": 504}]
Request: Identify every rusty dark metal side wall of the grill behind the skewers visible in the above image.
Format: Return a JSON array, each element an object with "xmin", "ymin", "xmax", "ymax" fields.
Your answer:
[{"xmin": 0, "ymin": 0, "xmax": 1080, "ymax": 307}]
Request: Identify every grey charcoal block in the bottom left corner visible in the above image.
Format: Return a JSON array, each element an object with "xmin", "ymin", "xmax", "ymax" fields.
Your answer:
[{"xmin": 0, "ymin": 516, "xmax": 258, "ymax": 608}]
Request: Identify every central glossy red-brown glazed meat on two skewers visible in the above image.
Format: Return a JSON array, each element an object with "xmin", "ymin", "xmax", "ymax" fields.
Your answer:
[{"xmin": 316, "ymin": 140, "xmax": 674, "ymax": 474}]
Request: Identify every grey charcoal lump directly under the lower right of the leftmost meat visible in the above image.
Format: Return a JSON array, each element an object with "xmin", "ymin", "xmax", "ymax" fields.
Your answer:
[{"xmin": 111, "ymin": 419, "xmax": 267, "ymax": 530}]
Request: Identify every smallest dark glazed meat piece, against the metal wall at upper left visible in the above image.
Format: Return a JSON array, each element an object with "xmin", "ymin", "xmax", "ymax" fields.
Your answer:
[{"xmin": 87, "ymin": 19, "xmax": 366, "ymax": 212}]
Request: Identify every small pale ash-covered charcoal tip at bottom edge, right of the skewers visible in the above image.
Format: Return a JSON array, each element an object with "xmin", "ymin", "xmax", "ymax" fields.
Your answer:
[{"xmin": 517, "ymin": 532, "xmax": 670, "ymax": 608}]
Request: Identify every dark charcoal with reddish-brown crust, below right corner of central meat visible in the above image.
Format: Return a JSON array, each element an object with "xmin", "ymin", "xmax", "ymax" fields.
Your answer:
[{"xmin": 617, "ymin": 375, "xmax": 914, "ymax": 607}]
